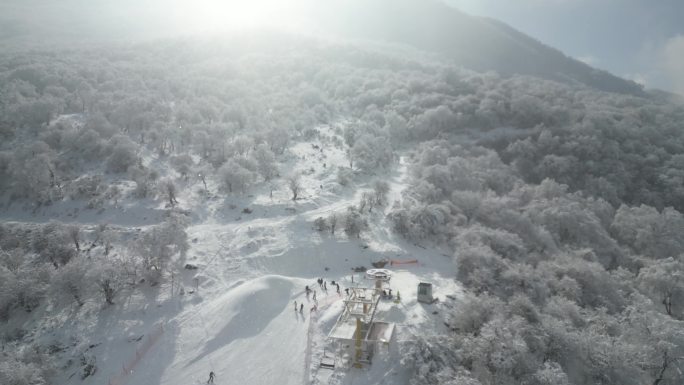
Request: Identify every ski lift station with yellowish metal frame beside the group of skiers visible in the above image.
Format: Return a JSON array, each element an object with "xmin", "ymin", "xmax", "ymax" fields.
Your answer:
[{"xmin": 321, "ymin": 269, "xmax": 395, "ymax": 369}]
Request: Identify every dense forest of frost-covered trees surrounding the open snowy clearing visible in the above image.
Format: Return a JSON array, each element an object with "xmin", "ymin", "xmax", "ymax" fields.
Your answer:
[{"xmin": 0, "ymin": 37, "xmax": 684, "ymax": 385}]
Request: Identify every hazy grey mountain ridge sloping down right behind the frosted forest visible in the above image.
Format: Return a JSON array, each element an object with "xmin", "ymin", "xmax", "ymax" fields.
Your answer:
[{"xmin": 321, "ymin": 0, "xmax": 644, "ymax": 95}]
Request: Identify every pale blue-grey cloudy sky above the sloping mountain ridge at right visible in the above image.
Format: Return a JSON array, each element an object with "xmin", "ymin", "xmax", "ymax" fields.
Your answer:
[{"xmin": 446, "ymin": 0, "xmax": 684, "ymax": 92}]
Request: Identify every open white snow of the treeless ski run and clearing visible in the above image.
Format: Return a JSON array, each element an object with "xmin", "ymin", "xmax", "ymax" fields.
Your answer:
[{"xmin": 5, "ymin": 123, "xmax": 461, "ymax": 385}]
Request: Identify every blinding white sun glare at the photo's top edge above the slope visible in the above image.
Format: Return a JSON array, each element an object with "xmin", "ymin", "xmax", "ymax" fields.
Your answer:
[{"xmin": 174, "ymin": 0, "xmax": 310, "ymax": 31}]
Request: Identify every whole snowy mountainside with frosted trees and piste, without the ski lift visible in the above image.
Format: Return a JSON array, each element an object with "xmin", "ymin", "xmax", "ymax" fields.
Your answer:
[{"xmin": 0, "ymin": 27, "xmax": 684, "ymax": 385}]
